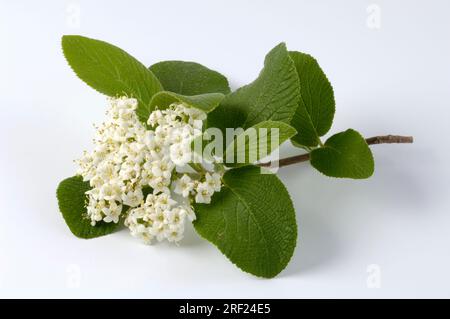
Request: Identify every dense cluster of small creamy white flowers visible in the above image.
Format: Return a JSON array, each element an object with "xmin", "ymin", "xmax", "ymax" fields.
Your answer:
[{"xmin": 76, "ymin": 97, "xmax": 222, "ymax": 243}]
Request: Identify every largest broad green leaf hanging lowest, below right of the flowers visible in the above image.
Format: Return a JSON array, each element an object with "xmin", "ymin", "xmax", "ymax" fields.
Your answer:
[{"xmin": 194, "ymin": 166, "xmax": 297, "ymax": 278}]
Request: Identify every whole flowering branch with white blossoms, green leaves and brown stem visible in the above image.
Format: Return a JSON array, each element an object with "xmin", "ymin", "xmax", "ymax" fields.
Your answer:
[{"xmin": 57, "ymin": 35, "xmax": 413, "ymax": 278}]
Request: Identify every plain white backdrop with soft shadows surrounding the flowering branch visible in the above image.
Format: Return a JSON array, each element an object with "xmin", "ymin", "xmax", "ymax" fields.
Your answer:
[{"xmin": 0, "ymin": 0, "xmax": 450, "ymax": 298}]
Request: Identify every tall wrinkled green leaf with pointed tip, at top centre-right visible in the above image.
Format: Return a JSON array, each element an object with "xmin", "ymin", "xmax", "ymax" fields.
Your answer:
[{"xmin": 208, "ymin": 43, "xmax": 300, "ymax": 132}]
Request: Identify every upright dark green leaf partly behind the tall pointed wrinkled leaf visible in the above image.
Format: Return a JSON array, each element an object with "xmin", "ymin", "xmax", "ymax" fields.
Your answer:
[{"xmin": 289, "ymin": 51, "xmax": 335, "ymax": 147}]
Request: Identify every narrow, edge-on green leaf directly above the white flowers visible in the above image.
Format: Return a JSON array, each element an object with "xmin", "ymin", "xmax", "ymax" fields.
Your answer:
[{"xmin": 150, "ymin": 91, "xmax": 225, "ymax": 113}]
